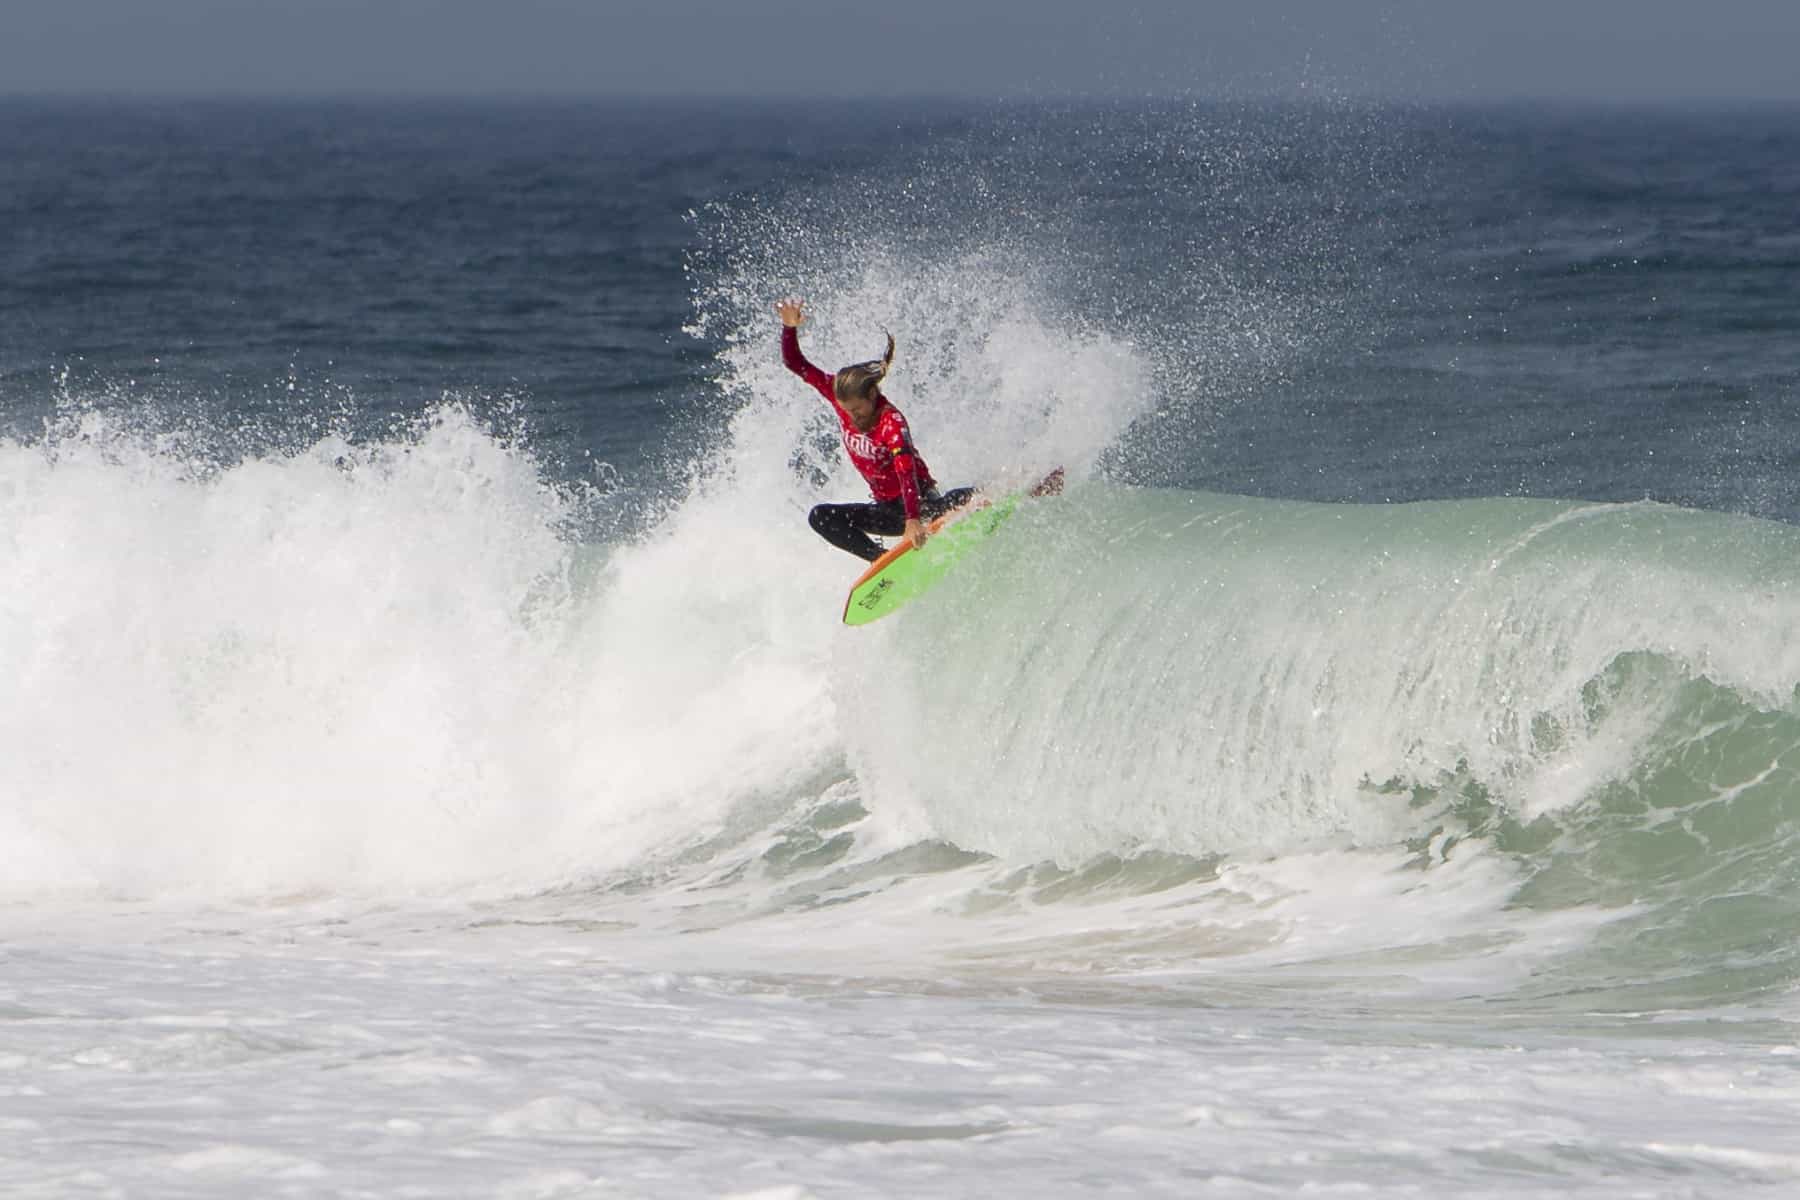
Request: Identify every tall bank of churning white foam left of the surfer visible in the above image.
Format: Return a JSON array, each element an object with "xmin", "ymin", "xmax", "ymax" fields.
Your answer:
[{"xmin": 0, "ymin": 408, "xmax": 835, "ymax": 894}]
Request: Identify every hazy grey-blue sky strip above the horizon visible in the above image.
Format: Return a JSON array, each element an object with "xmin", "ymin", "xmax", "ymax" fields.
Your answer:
[{"xmin": 0, "ymin": 0, "xmax": 1800, "ymax": 103}]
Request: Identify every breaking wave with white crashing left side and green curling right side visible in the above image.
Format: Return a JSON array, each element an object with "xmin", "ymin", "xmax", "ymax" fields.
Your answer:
[{"xmin": 0, "ymin": 394, "xmax": 1800, "ymax": 999}]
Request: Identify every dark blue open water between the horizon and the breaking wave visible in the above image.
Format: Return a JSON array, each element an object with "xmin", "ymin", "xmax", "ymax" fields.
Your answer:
[{"xmin": 0, "ymin": 101, "xmax": 1800, "ymax": 520}]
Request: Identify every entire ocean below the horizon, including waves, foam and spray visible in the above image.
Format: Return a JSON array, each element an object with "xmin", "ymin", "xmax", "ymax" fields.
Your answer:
[{"xmin": 0, "ymin": 97, "xmax": 1800, "ymax": 1200}]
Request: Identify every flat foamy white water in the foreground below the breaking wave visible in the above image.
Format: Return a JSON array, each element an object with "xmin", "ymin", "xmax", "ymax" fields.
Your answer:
[{"xmin": 0, "ymin": 905, "xmax": 1800, "ymax": 1200}]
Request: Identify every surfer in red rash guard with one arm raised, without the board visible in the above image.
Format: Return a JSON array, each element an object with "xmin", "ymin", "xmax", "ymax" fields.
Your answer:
[{"xmin": 776, "ymin": 299, "xmax": 976, "ymax": 563}]
